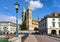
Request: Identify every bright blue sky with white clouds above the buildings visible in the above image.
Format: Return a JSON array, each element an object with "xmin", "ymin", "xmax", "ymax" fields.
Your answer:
[{"xmin": 0, "ymin": 0, "xmax": 60, "ymax": 24}]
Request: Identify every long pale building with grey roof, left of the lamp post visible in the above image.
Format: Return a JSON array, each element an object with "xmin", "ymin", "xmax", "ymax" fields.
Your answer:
[{"xmin": 0, "ymin": 21, "xmax": 19, "ymax": 34}]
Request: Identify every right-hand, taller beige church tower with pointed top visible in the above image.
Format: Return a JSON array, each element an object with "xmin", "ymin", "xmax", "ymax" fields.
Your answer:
[{"xmin": 26, "ymin": 3, "xmax": 32, "ymax": 30}]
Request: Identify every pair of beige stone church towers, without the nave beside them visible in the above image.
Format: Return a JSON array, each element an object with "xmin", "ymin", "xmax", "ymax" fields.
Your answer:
[{"xmin": 22, "ymin": 4, "xmax": 32, "ymax": 30}]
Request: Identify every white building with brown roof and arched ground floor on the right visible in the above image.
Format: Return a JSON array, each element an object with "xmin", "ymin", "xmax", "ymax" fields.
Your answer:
[{"xmin": 39, "ymin": 12, "xmax": 60, "ymax": 35}]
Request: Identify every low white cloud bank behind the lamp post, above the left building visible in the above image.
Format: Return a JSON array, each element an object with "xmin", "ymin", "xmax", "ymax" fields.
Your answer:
[{"xmin": 0, "ymin": 14, "xmax": 21, "ymax": 24}]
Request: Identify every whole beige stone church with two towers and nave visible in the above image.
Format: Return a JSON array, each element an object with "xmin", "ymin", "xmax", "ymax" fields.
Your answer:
[{"xmin": 22, "ymin": 4, "xmax": 38, "ymax": 30}]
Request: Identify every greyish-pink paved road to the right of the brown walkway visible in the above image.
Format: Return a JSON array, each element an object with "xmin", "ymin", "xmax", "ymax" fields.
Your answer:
[{"xmin": 35, "ymin": 35, "xmax": 60, "ymax": 42}]
